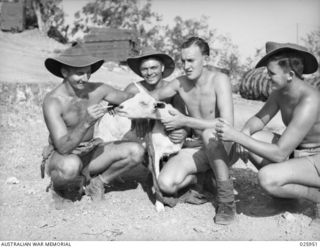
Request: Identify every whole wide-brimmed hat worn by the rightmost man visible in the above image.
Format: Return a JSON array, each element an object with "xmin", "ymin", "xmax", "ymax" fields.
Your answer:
[{"xmin": 256, "ymin": 41, "xmax": 318, "ymax": 74}]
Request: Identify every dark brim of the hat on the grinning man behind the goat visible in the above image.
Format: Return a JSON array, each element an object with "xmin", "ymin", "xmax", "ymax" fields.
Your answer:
[{"xmin": 127, "ymin": 53, "xmax": 175, "ymax": 78}]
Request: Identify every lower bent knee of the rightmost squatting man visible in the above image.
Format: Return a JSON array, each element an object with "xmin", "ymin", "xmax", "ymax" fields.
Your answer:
[{"xmin": 258, "ymin": 166, "xmax": 281, "ymax": 194}]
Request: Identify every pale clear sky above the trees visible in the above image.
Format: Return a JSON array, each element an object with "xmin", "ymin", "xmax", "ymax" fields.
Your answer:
[{"xmin": 63, "ymin": 0, "xmax": 320, "ymax": 58}]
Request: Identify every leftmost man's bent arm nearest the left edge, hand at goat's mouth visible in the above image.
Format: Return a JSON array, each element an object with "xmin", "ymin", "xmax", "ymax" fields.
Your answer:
[{"xmin": 43, "ymin": 97, "xmax": 99, "ymax": 154}]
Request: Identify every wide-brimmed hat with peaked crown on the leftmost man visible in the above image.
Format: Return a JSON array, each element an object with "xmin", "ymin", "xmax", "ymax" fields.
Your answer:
[{"xmin": 44, "ymin": 43, "xmax": 104, "ymax": 78}]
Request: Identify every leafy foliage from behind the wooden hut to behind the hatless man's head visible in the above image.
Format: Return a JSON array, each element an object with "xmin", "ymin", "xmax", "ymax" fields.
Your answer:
[{"xmin": 72, "ymin": 0, "xmax": 242, "ymax": 83}]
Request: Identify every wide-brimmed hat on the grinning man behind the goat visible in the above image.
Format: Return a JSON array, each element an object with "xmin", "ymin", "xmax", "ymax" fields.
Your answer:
[{"xmin": 127, "ymin": 47, "xmax": 175, "ymax": 78}]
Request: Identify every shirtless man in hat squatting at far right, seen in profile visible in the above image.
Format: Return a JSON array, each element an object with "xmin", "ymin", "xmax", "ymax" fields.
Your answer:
[{"xmin": 216, "ymin": 42, "xmax": 320, "ymax": 223}]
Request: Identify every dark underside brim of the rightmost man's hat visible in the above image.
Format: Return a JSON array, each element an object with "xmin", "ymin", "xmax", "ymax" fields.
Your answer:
[{"xmin": 256, "ymin": 47, "xmax": 318, "ymax": 74}]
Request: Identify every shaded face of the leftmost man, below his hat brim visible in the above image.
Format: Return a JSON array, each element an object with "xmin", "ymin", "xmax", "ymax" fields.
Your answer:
[{"xmin": 61, "ymin": 66, "xmax": 91, "ymax": 90}]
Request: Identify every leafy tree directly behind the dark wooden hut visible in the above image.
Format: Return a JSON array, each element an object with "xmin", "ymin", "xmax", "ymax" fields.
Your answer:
[{"xmin": 72, "ymin": 0, "xmax": 161, "ymax": 46}]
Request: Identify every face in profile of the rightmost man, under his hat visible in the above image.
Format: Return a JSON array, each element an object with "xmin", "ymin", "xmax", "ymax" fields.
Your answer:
[{"xmin": 267, "ymin": 61, "xmax": 290, "ymax": 90}]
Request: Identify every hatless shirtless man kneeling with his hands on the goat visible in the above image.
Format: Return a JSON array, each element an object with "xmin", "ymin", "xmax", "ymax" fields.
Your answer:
[{"xmin": 151, "ymin": 37, "xmax": 236, "ymax": 225}]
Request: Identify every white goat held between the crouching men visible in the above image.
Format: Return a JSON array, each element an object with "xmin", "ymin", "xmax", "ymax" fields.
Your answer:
[{"xmin": 97, "ymin": 84, "xmax": 182, "ymax": 212}]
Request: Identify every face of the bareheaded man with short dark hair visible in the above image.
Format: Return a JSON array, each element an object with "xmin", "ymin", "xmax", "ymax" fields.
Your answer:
[{"xmin": 181, "ymin": 45, "xmax": 208, "ymax": 80}]
